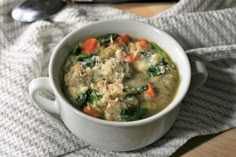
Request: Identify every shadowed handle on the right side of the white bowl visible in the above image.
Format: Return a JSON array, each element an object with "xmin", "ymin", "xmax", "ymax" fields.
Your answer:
[{"xmin": 188, "ymin": 56, "xmax": 208, "ymax": 93}]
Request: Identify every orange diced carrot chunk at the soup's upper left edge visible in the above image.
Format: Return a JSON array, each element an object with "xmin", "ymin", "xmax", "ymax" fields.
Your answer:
[{"xmin": 81, "ymin": 38, "xmax": 98, "ymax": 54}]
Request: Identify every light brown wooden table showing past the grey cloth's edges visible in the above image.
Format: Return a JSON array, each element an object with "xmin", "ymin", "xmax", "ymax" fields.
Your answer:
[{"xmin": 113, "ymin": 3, "xmax": 236, "ymax": 157}]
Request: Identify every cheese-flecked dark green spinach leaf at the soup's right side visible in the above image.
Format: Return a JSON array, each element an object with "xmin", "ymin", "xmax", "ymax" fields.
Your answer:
[{"xmin": 148, "ymin": 59, "xmax": 169, "ymax": 77}]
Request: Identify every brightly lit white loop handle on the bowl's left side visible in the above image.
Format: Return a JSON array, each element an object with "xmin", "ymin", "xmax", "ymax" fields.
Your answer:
[{"xmin": 29, "ymin": 77, "xmax": 59, "ymax": 114}]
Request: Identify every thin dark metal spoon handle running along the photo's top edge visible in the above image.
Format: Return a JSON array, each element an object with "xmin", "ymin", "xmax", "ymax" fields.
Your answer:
[{"xmin": 63, "ymin": 0, "xmax": 179, "ymax": 4}]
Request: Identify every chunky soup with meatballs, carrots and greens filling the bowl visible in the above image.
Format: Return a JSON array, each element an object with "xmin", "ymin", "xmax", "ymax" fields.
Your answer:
[{"xmin": 63, "ymin": 33, "xmax": 179, "ymax": 121}]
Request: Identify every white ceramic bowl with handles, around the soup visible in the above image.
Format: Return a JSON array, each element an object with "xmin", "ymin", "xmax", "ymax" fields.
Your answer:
[{"xmin": 29, "ymin": 20, "xmax": 207, "ymax": 151}]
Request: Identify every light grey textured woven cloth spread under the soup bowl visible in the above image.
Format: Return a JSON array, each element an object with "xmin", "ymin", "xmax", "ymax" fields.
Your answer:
[{"xmin": 0, "ymin": 0, "xmax": 236, "ymax": 157}]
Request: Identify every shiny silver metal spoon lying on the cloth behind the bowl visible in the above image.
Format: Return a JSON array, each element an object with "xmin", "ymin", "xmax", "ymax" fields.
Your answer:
[{"xmin": 11, "ymin": 0, "xmax": 176, "ymax": 22}]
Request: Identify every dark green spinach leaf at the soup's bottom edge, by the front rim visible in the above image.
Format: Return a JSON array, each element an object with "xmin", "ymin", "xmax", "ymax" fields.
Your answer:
[{"xmin": 120, "ymin": 106, "xmax": 148, "ymax": 121}]
